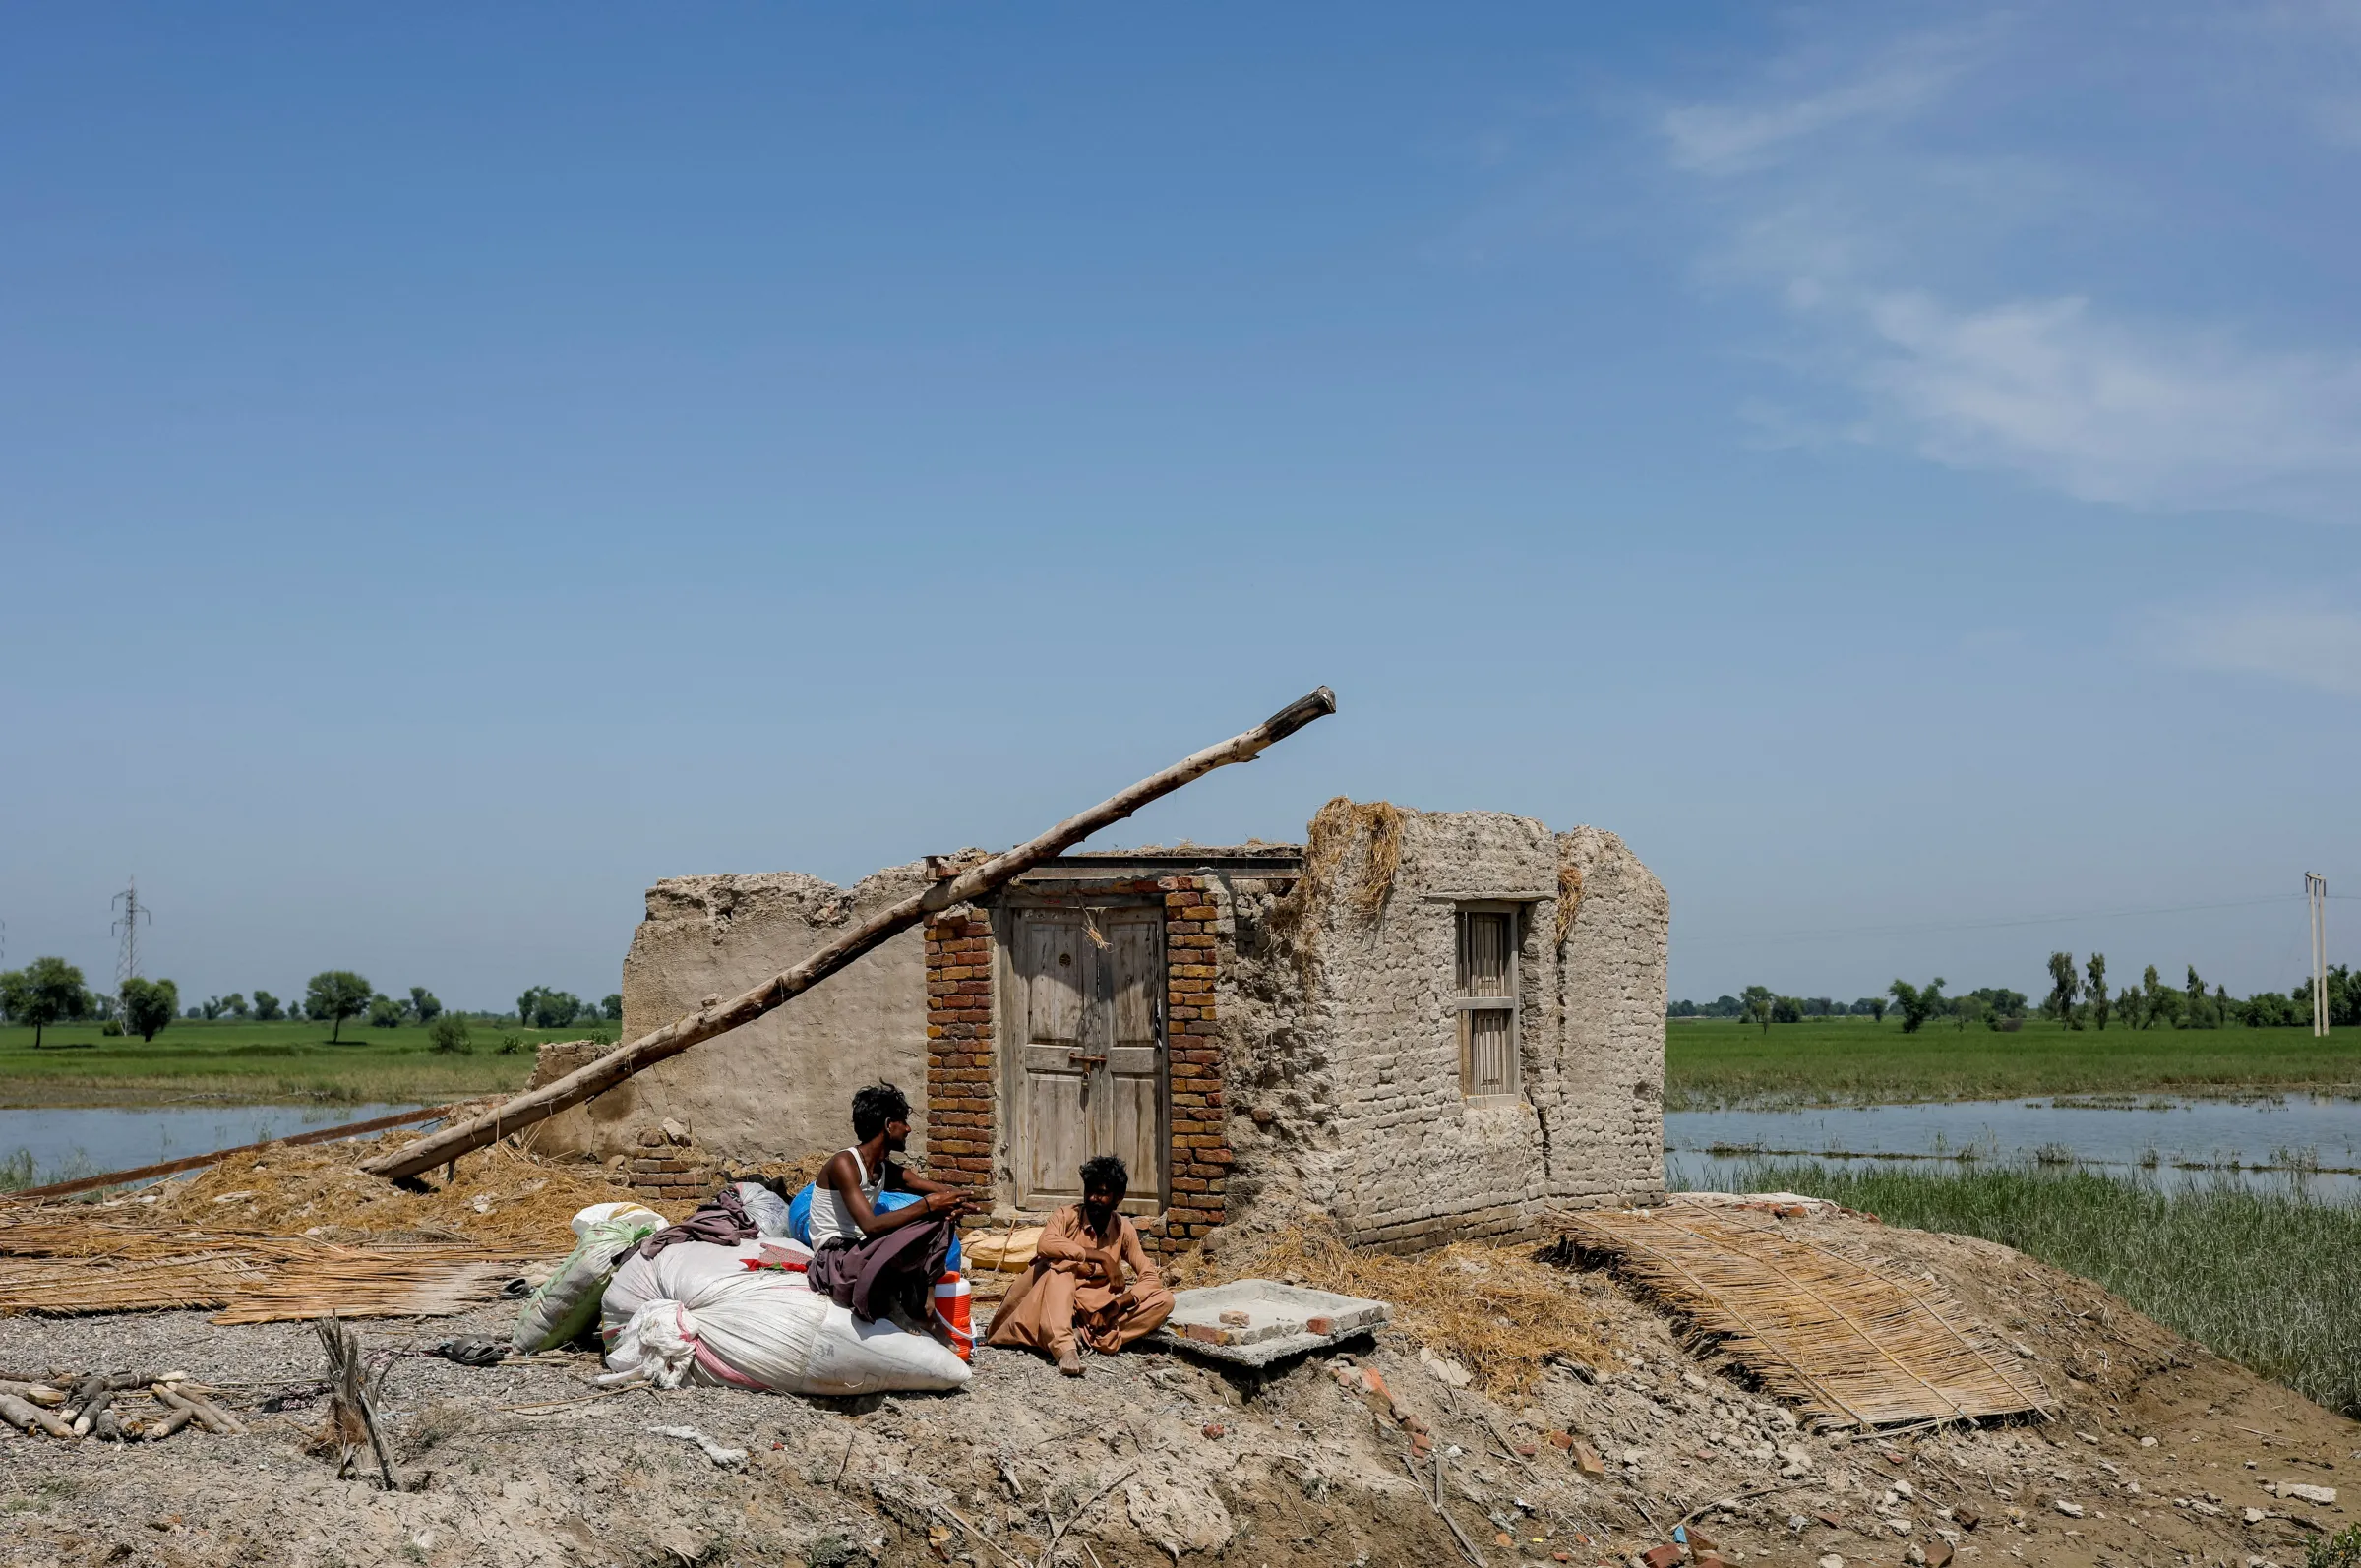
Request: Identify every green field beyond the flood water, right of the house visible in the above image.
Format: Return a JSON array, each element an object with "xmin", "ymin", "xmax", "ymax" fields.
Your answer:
[{"xmin": 1665, "ymin": 1018, "xmax": 2361, "ymax": 1110}]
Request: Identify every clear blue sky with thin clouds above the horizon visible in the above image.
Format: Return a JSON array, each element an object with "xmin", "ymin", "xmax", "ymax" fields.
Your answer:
[{"xmin": 0, "ymin": 5, "xmax": 2361, "ymax": 1006}]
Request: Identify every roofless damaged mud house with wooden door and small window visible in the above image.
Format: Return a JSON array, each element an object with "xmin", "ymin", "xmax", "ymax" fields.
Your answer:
[{"xmin": 536, "ymin": 798, "xmax": 1666, "ymax": 1251}]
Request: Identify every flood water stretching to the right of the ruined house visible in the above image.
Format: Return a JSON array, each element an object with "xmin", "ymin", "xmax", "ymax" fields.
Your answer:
[{"xmin": 1665, "ymin": 1093, "xmax": 2361, "ymax": 1202}]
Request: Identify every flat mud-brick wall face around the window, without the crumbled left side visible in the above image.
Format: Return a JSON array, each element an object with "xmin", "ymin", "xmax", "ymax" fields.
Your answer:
[{"xmin": 1292, "ymin": 810, "xmax": 1666, "ymax": 1251}]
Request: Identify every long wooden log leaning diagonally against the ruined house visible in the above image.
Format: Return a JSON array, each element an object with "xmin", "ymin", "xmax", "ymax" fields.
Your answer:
[{"xmin": 361, "ymin": 688, "xmax": 1336, "ymax": 1180}]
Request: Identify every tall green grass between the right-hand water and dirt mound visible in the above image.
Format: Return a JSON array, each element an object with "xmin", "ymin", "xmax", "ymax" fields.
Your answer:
[{"xmin": 1700, "ymin": 1157, "xmax": 2361, "ymax": 1417}]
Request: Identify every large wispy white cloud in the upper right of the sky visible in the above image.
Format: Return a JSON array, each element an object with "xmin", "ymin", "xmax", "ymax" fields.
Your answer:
[{"xmin": 1658, "ymin": 10, "xmax": 2361, "ymax": 522}]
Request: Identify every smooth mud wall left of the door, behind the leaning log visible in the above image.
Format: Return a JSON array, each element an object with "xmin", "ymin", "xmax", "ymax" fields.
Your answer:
[{"xmin": 538, "ymin": 862, "xmax": 928, "ymax": 1164}]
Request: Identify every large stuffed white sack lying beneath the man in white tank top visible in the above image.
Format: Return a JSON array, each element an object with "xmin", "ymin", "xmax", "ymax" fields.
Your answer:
[{"xmin": 607, "ymin": 1242, "xmax": 968, "ymax": 1396}]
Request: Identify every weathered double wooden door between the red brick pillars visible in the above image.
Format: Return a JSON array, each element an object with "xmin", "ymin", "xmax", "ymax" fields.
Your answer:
[{"xmin": 1008, "ymin": 907, "xmax": 1167, "ymax": 1214}]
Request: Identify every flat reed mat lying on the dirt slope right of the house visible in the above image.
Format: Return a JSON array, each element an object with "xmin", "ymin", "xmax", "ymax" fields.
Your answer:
[{"xmin": 1565, "ymin": 1209, "xmax": 2052, "ymax": 1426}]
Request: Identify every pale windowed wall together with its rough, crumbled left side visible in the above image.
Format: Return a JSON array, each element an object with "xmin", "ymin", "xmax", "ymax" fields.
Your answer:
[{"xmin": 1223, "ymin": 801, "xmax": 1666, "ymax": 1249}]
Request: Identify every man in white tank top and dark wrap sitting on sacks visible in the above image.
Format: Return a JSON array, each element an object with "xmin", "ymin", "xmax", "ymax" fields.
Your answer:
[{"xmin": 805, "ymin": 1084, "xmax": 973, "ymax": 1322}]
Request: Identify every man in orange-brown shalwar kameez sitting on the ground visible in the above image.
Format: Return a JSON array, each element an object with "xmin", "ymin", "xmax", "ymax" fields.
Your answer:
[{"xmin": 987, "ymin": 1155, "xmax": 1174, "ymax": 1377}]
